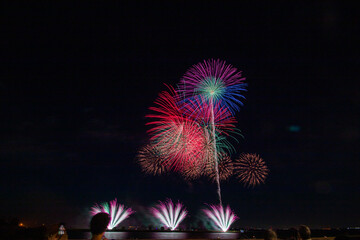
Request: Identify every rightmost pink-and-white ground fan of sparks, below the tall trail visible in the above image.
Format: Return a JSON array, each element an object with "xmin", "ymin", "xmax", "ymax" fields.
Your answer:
[{"xmin": 203, "ymin": 205, "xmax": 238, "ymax": 232}]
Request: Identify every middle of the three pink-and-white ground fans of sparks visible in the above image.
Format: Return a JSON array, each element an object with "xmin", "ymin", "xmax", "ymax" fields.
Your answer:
[{"xmin": 151, "ymin": 199, "xmax": 187, "ymax": 231}]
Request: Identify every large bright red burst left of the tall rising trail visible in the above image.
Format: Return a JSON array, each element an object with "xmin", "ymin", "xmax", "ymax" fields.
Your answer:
[{"xmin": 147, "ymin": 86, "xmax": 208, "ymax": 171}]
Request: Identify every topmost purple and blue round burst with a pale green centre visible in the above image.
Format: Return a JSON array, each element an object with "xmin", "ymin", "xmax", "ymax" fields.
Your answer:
[{"xmin": 179, "ymin": 59, "xmax": 246, "ymax": 112}]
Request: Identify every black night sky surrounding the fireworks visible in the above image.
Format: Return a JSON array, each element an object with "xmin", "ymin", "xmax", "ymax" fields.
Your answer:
[{"xmin": 0, "ymin": 1, "xmax": 360, "ymax": 227}]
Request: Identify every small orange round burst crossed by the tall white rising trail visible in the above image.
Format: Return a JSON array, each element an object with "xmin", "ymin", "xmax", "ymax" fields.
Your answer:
[{"xmin": 206, "ymin": 153, "xmax": 234, "ymax": 182}]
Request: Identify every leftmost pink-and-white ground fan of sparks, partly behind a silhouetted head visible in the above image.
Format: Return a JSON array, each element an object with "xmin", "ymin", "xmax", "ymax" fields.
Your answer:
[{"xmin": 91, "ymin": 198, "xmax": 135, "ymax": 230}]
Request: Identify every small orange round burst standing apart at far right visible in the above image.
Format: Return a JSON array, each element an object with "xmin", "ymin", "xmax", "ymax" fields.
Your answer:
[{"xmin": 234, "ymin": 153, "xmax": 269, "ymax": 187}]
